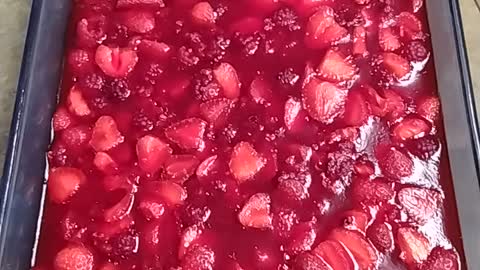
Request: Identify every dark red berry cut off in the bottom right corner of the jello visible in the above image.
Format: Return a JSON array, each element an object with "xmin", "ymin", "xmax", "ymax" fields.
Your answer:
[{"xmin": 420, "ymin": 247, "xmax": 460, "ymax": 270}]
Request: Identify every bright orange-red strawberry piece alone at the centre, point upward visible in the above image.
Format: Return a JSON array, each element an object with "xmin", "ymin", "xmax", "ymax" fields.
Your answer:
[{"xmin": 228, "ymin": 142, "xmax": 266, "ymax": 183}]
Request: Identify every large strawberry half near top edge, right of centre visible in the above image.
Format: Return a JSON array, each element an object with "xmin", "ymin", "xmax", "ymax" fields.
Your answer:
[{"xmin": 305, "ymin": 6, "xmax": 348, "ymax": 49}]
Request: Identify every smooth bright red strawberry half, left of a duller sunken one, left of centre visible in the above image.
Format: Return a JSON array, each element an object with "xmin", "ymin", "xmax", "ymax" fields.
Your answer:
[{"xmin": 136, "ymin": 135, "xmax": 173, "ymax": 173}]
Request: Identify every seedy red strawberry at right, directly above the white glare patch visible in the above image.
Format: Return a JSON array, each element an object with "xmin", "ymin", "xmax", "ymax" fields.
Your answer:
[{"xmin": 375, "ymin": 145, "xmax": 413, "ymax": 179}]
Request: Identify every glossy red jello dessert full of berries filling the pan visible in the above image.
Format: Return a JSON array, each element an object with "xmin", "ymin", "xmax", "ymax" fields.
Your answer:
[{"xmin": 34, "ymin": 0, "xmax": 465, "ymax": 270}]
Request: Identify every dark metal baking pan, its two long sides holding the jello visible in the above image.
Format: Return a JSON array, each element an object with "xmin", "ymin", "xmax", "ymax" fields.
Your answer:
[{"xmin": 0, "ymin": 0, "xmax": 480, "ymax": 270}]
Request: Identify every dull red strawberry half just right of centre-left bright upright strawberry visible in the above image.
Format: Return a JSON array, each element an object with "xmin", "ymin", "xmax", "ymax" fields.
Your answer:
[{"xmin": 164, "ymin": 155, "xmax": 200, "ymax": 183}]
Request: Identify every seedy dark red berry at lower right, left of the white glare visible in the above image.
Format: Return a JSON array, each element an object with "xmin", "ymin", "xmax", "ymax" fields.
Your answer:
[{"xmin": 352, "ymin": 178, "xmax": 395, "ymax": 204}]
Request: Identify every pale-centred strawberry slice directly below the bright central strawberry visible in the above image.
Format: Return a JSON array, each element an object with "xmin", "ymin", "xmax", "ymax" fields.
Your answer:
[{"xmin": 238, "ymin": 193, "xmax": 272, "ymax": 229}]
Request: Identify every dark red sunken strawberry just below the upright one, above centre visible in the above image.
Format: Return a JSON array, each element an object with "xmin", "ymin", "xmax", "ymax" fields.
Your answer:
[{"xmin": 200, "ymin": 98, "xmax": 234, "ymax": 128}]
